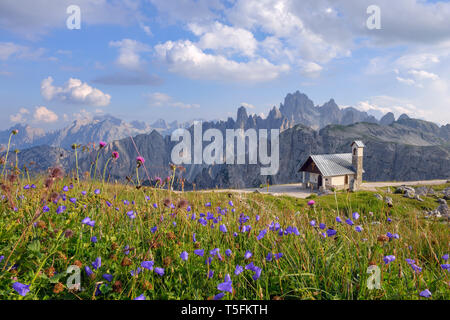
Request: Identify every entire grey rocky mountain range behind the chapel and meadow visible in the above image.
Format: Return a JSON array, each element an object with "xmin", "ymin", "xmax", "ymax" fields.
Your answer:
[{"xmin": 4, "ymin": 91, "xmax": 450, "ymax": 189}]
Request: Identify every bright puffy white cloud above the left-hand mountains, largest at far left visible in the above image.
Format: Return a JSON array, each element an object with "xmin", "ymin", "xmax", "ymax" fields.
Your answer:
[{"xmin": 41, "ymin": 77, "xmax": 111, "ymax": 107}]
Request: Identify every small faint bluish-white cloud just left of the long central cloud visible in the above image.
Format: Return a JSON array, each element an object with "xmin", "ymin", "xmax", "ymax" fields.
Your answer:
[{"xmin": 109, "ymin": 39, "xmax": 151, "ymax": 70}]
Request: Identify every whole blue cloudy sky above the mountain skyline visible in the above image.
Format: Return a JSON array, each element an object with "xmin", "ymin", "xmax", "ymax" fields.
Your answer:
[{"xmin": 0, "ymin": 0, "xmax": 450, "ymax": 130}]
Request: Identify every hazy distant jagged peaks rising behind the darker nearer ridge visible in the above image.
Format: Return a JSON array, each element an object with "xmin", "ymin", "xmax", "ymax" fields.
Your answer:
[{"xmin": 0, "ymin": 91, "xmax": 450, "ymax": 149}]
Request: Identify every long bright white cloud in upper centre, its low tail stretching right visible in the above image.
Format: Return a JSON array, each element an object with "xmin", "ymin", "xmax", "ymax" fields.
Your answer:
[{"xmin": 155, "ymin": 40, "xmax": 289, "ymax": 82}]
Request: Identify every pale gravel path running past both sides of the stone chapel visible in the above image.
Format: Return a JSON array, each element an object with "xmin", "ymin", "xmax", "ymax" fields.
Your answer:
[{"xmin": 203, "ymin": 180, "xmax": 447, "ymax": 199}]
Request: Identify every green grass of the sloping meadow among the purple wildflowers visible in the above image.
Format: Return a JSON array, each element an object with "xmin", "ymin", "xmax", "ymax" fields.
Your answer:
[{"xmin": 0, "ymin": 172, "xmax": 450, "ymax": 300}]
